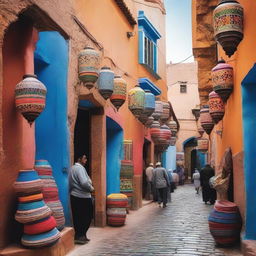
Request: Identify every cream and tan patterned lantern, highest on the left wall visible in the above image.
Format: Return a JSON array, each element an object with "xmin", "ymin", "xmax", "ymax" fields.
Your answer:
[{"xmin": 78, "ymin": 47, "xmax": 100, "ymax": 89}]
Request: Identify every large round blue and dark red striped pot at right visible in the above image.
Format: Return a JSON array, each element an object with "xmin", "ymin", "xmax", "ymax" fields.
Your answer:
[{"xmin": 208, "ymin": 201, "xmax": 242, "ymax": 246}]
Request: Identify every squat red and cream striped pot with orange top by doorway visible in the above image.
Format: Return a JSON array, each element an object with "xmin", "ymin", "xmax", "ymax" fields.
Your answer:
[{"xmin": 107, "ymin": 193, "xmax": 128, "ymax": 227}]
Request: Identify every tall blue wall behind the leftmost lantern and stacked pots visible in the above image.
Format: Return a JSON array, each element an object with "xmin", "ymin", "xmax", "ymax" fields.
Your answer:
[{"xmin": 35, "ymin": 32, "xmax": 70, "ymax": 224}]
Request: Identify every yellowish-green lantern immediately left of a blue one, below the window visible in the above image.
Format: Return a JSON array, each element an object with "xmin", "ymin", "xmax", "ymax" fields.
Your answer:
[{"xmin": 128, "ymin": 85, "xmax": 145, "ymax": 117}]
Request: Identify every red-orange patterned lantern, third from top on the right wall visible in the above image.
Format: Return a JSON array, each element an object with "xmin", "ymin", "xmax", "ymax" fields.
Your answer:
[{"xmin": 209, "ymin": 91, "xmax": 225, "ymax": 124}]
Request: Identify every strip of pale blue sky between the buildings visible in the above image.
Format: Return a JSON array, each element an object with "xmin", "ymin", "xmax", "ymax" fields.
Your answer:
[{"xmin": 164, "ymin": 0, "xmax": 193, "ymax": 63}]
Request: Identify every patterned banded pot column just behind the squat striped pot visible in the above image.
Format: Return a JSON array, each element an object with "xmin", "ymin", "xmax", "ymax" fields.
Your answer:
[{"xmin": 120, "ymin": 160, "xmax": 134, "ymax": 208}]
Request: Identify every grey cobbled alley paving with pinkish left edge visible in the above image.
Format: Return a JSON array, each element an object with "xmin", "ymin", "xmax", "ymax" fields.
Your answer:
[{"xmin": 69, "ymin": 185, "xmax": 242, "ymax": 256}]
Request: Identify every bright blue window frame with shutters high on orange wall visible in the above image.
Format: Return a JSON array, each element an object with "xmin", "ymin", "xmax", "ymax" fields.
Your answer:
[{"xmin": 138, "ymin": 11, "xmax": 161, "ymax": 79}]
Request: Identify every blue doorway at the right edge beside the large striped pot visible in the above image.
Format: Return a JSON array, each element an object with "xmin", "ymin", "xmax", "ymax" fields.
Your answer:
[{"xmin": 242, "ymin": 64, "xmax": 256, "ymax": 240}]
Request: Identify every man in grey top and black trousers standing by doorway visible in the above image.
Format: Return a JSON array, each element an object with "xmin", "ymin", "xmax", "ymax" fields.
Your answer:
[{"xmin": 69, "ymin": 155, "xmax": 94, "ymax": 244}]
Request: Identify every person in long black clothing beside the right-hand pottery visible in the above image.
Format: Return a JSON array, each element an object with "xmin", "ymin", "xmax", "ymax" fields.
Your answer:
[{"xmin": 200, "ymin": 164, "xmax": 216, "ymax": 204}]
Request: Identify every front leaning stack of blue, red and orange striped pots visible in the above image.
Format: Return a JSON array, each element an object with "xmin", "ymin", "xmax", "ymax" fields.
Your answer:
[{"xmin": 14, "ymin": 170, "xmax": 60, "ymax": 248}]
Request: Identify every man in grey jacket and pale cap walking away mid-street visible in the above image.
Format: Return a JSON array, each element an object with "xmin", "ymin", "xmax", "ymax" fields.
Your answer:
[{"xmin": 153, "ymin": 162, "xmax": 170, "ymax": 208}]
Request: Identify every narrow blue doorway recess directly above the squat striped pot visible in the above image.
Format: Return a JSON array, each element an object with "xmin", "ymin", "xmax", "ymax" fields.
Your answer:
[{"xmin": 107, "ymin": 117, "xmax": 123, "ymax": 195}]
